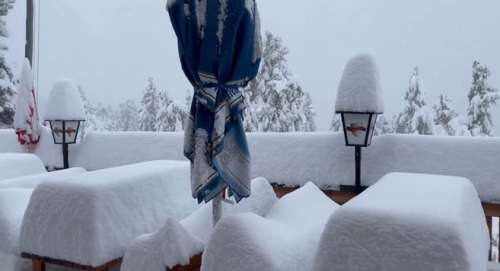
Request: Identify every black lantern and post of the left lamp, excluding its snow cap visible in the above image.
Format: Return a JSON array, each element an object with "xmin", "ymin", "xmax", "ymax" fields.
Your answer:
[{"xmin": 48, "ymin": 120, "xmax": 84, "ymax": 169}]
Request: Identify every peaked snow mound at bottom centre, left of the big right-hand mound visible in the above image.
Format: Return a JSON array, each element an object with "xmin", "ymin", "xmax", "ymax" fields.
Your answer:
[{"xmin": 201, "ymin": 183, "xmax": 341, "ymax": 271}]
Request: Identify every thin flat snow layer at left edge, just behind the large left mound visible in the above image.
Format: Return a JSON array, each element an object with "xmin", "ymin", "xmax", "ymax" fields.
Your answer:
[{"xmin": 0, "ymin": 168, "xmax": 86, "ymax": 189}]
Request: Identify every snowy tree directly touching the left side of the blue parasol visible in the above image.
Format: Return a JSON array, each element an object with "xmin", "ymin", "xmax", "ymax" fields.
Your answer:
[{"xmin": 156, "ymin": 91, "xmax": 187, "ymax": 132}]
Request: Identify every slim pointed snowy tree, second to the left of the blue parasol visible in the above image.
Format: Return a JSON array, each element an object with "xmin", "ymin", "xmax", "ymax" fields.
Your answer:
[{"xmin": 139, "ymin": 77, "xmax": 160, "ymax": 131}]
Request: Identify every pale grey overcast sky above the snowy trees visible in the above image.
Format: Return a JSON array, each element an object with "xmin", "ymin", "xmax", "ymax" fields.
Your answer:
[{"xmin": 4, "ymin": 0, "xmax": 500, "ymax": 134}]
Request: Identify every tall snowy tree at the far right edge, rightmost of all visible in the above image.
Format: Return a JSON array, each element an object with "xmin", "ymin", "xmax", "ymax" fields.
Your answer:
[{"xmin": 467, "ymin": 61, "xmax": 499, "ymax": 136}]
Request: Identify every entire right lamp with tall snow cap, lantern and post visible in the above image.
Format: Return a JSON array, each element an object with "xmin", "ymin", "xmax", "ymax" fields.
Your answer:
[{"xmin": 335, "ymin": 54, "xmax": 384, "ymax": 193}]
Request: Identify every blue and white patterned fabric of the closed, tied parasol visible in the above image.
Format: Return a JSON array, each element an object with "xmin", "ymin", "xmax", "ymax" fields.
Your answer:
[{"xmin": 167, "ymin": 0, "xmax": 262, "ymax": 202}]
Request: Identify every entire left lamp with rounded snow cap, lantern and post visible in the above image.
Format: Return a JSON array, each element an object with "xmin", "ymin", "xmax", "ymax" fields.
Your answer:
[{"xmin": 45, "ymin": 80, "xmax": 86, "ymax": 168}]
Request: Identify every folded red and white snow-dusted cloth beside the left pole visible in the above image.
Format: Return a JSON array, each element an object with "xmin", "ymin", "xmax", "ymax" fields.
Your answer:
[{"xmin": 14, "ymin": 59, "xmax": 40, "ymax": 150}]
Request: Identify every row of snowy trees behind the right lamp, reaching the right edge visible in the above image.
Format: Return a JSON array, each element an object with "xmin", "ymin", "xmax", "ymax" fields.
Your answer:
[{"xmin": 331, "ymin": 61, "xmax": 500, "ymax": 136}]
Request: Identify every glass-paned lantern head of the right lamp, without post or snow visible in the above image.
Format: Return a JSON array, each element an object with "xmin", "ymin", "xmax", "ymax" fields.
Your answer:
[{"xmin": 344, "ymin": 113, "xmax": 370, "ymax": 146}]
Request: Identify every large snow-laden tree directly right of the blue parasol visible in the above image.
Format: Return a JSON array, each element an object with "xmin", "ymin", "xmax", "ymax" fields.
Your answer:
[{"xmin": 244, "ymin": 32, "xmax": 316, "ymax": 132}]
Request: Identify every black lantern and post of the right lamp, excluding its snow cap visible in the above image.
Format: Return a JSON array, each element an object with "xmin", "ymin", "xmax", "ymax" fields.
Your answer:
[{"xmin": 337, "ymin": 111, "xmax": 378, "ymax": 194}]
